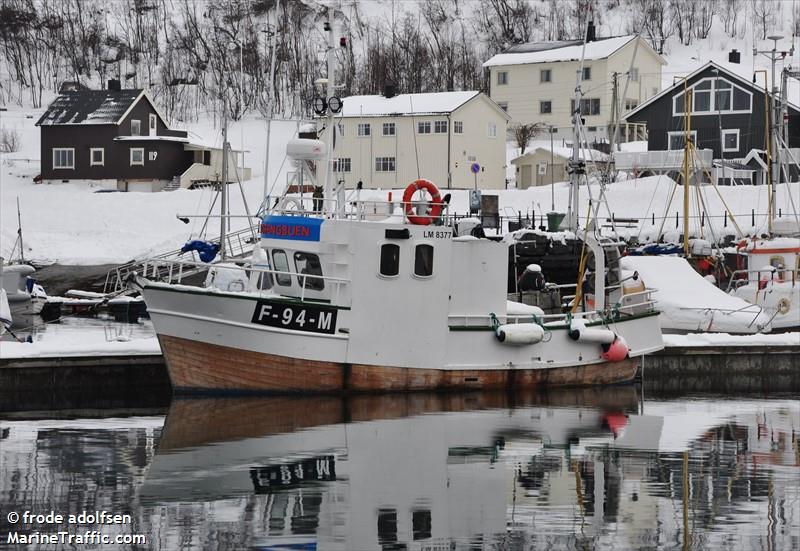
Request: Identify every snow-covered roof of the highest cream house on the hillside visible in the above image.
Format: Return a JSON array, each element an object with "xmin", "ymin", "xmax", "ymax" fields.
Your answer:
[{"xmin": 483, "ymin": 34, "xmax": 636, "ymax": 67}]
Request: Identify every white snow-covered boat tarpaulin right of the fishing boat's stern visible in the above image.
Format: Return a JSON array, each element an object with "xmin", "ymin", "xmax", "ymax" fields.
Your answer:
[{"xmin": 620, "ymin": 256, "xmax": 770, "ymax": 333}]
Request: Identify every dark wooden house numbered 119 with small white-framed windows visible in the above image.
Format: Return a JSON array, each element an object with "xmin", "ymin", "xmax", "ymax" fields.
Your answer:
[{"xmin": 36, "ymin": 81, "xmax": 202, "ymax": 191}]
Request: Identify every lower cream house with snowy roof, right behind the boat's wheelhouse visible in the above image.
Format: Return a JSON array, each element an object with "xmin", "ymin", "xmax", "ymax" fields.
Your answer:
[{"xmin": 320, "ymin": 91, "xmax": 509, "ymax": 189}]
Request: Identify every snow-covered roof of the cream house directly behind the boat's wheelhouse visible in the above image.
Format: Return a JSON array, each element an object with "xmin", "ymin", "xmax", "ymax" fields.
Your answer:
[{"xmin": 342, "ymin": 91, "xmax": 480, "ymax": 117}]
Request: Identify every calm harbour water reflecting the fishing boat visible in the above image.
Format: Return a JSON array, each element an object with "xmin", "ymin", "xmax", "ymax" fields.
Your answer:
[{"xmin": 0, "ymin": 387, "xmax": 800, "ymax": 551}]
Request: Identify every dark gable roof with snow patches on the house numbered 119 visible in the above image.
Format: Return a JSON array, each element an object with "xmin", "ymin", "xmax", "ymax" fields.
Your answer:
[{"xmin": 36, "ymin": 89, "xmax": 169, "ymax": 128}]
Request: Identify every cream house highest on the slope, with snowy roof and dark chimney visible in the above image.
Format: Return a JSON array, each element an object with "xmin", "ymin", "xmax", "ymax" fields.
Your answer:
[{"xmin": 483, "ymin": 25, "xmax": 666, "ymax": 141}]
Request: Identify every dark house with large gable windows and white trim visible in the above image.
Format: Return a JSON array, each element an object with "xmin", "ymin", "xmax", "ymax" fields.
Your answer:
[{"xmin": 624, "ymin": 62, "xmax": 800, "ymax": 164}]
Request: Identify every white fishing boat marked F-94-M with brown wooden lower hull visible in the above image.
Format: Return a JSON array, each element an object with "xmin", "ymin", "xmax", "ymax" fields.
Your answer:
[{"xmin": 131, "ymin": 11, "xmax": 663, "ymax": 392}]
